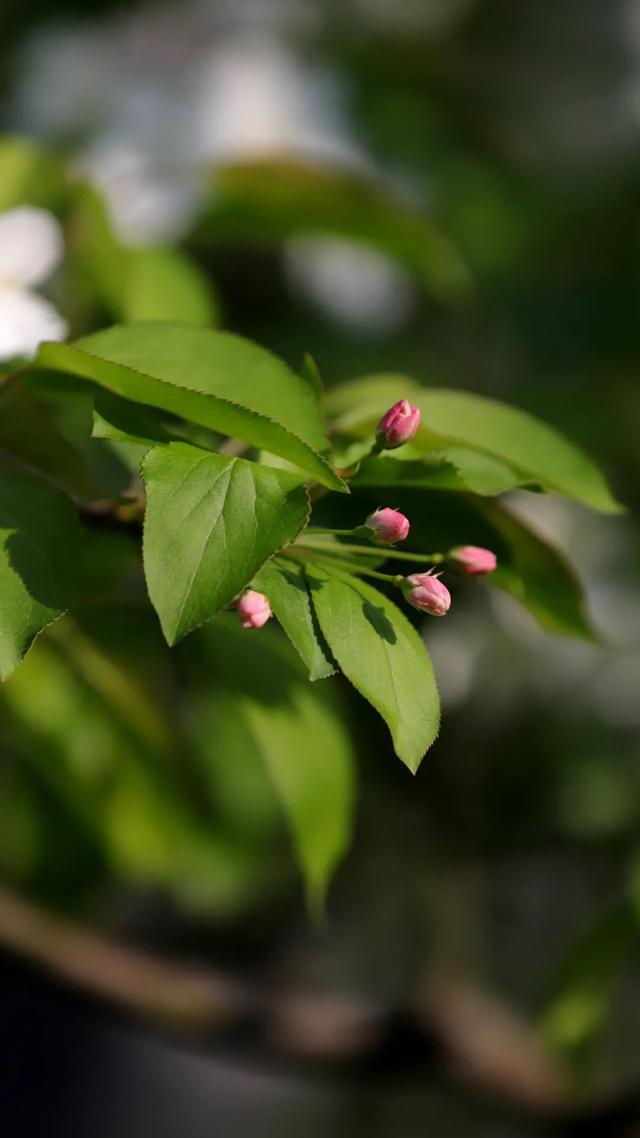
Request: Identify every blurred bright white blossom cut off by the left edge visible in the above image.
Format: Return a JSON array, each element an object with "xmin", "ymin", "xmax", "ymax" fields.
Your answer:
[{"xmin": 0, "ymin": 206, "xmax": 67, "ymax": 361}]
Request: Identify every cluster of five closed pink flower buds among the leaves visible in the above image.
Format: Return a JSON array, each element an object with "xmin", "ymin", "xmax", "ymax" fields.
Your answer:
[{"xmin": 236, "ymin": 399, "xmax": 497, "ymax": 628}]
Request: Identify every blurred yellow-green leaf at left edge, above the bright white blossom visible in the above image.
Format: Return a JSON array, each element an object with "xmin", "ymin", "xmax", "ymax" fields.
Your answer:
[{"xmin": 0, "ymin": 135, "xmax": 67, "ymax": 212}]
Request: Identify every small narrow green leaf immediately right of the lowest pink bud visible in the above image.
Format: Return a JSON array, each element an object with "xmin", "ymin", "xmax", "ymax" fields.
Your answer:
[{"xmin": 253, "ymin": 558, "xmax": 336, "ymax": 679}]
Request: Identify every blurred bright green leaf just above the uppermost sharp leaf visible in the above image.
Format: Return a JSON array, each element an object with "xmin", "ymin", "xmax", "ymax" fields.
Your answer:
[{"xmin": 116, "ymin": 246, "xmax": 218, "ymax": 324}]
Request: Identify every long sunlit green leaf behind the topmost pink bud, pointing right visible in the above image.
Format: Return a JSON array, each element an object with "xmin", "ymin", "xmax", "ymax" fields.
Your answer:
[{"xmin": 328, "ymin": 376, "xmax": 621, "ymax": 513}]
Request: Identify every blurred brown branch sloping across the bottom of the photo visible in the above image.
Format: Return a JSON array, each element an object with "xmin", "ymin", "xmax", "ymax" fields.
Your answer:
[{"xmin": 0, "ymin": 888, "xmax": 640, "ymax": 1138}]
